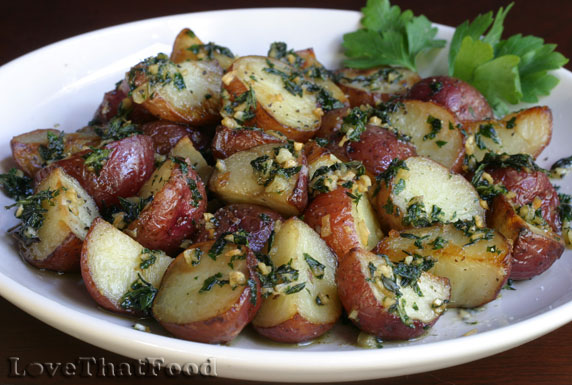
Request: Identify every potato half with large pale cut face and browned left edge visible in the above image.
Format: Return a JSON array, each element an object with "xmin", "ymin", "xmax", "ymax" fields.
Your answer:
[{"xmin": 372, "ymin": 157, "xmax": 485, "ymax": 231}]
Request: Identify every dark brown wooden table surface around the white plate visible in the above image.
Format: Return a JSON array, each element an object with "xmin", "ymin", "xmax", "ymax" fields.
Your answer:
[{"xmin": 0, "ymin": 0, "xmax": 572, "ymax": 385}]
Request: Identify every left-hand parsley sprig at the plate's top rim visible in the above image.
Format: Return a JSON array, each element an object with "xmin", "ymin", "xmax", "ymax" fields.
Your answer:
[{"xmin": 343, "ymin": 0, "xmax": 445, "ymax": 71}]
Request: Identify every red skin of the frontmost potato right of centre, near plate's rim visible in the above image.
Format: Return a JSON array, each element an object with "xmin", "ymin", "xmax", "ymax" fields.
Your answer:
[{"xmin": 336, "ymin": 248, "xmax": 438, "ymax": 340}]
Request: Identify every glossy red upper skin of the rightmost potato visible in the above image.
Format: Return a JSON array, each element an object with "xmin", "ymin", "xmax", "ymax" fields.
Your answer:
[{"xmin": 487, "ymin": 168, "xmax": 562, "ymax": 232}]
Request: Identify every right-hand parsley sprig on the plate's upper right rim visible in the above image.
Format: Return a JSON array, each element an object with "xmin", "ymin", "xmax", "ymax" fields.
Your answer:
[{"xmin": 449, "ymin": 3, "xmax": 568, "ymax": 115}]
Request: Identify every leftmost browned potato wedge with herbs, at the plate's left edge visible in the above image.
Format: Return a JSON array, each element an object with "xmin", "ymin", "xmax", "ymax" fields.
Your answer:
[{"xmin": 10, "ymin": 129, "xmax": 101, "ymax": 176}]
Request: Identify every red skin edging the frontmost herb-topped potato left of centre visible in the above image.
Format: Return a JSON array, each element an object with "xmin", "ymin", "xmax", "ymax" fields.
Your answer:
[{"xmin": 159, "ymin": 242, "xmax": 262, "ymax": 344}]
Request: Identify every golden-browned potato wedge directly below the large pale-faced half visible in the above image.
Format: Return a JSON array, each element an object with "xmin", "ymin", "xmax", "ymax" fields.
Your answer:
[{"xmin": 375, "ymin": 223, "xmax": 511, "ymax": 308}]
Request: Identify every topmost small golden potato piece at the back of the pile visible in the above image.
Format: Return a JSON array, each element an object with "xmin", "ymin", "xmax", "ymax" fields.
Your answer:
[{"xmin": 171, "ymin": 28, "xmax": 234, "ymax": 70}]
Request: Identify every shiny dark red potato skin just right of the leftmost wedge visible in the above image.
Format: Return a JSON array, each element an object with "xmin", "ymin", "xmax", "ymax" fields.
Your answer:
[{"xmin": 35, "ymin": 135, "xmax": 155, "ymax": 208}]
